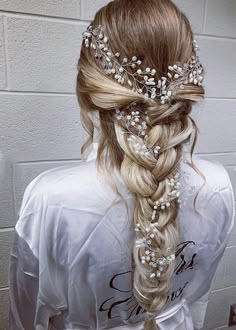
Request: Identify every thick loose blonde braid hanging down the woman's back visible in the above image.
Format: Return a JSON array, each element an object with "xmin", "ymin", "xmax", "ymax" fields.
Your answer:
[{"xmin": 115, "ymin": 102, "xmax": 194, "ymax": 330}]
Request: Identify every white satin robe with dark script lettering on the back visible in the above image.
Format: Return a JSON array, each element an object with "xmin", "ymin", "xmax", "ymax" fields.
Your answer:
[{"xmin": 9, "ymin": 142, "xmax": 235, "ymax": 330}]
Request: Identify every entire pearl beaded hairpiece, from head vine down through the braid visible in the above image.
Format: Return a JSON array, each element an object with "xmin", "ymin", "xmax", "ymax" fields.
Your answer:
[{"xmin": 83, "ymin": 25, "xmax": 200, "ymax": 278}]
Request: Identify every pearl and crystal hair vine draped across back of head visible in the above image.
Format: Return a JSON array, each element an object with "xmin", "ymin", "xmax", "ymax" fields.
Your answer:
[{"xmin": 83, "ymin": 25, "xmax": 203, "ymax": 104}]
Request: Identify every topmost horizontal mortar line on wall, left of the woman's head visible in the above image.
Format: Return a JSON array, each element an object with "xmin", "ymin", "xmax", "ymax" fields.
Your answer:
[{"xmin": 0, "ymin": 10, "xmax": 91, "ymax": 25}]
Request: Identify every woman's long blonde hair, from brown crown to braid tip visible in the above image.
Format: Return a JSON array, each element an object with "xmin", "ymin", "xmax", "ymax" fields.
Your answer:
[{"xmin": 77, "ymin": 0, "xmax": 204, "ymax": 330}]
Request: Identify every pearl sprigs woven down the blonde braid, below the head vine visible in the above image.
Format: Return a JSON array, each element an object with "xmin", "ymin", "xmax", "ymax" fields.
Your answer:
[{"xmin": 115, "ymin": 102, "xmax": 182, "ymax": 278}]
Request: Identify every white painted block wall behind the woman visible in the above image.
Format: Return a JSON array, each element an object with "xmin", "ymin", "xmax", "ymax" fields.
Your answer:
[{"xmin": 0, "ymin": 0, "xmax": 236, "ymax": 330}]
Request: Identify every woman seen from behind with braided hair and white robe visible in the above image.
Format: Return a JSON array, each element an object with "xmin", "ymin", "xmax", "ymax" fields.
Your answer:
[{"xmin": 10, "ymin": 0, "xmax": 235, "ymax": 330}]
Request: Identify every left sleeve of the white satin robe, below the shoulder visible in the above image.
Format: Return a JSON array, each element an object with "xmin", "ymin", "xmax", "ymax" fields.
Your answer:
[{"xmin": 9, "ymin": 204, "xmax": 67, "ymax": 330}]
